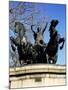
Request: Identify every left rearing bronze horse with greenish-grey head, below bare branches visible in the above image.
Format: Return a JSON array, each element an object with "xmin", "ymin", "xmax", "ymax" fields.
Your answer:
[{"xmin": 10, "ymin": 22, "xmax": 36, "ymax": 65}]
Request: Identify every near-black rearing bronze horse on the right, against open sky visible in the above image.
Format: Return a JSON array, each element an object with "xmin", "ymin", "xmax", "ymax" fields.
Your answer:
[{"xmin": 45, "ymin": 20, "xmax": 65, "ymax": 64}]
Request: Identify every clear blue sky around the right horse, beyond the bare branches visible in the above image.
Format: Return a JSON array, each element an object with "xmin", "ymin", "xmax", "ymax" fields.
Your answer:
[{"xmin": 9, "ymin": 2, "xmax": 66, "ymax": 64}]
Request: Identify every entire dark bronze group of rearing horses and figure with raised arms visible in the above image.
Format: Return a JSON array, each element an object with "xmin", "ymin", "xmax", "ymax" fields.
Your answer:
[{"xmin": 10, "ymin": 20, "xmax": 65, "ymax": 65}]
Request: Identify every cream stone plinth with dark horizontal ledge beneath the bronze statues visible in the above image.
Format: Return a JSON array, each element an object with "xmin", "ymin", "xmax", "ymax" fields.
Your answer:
[{"xmin": 9, "ymin": 64, "xmax": 66, "ymax": 89}]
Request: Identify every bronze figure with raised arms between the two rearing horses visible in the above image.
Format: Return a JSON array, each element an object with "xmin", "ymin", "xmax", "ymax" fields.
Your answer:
[{"xmin": 31, "ymin": 22, "xmax": 48, "ymax": 63}]
